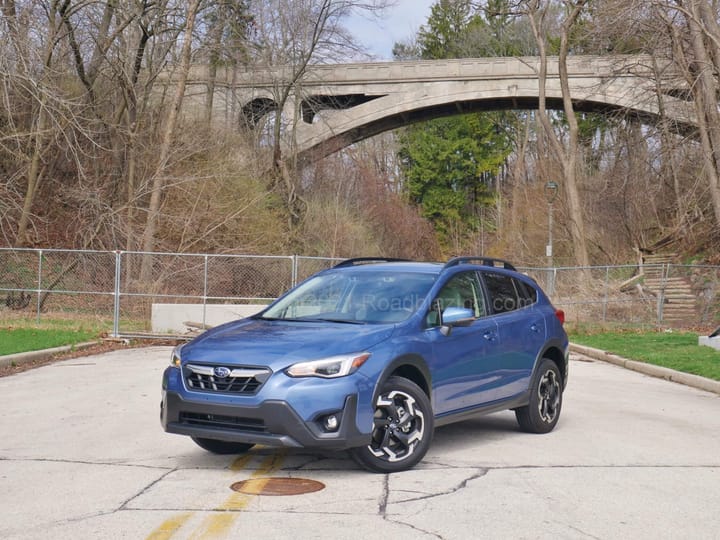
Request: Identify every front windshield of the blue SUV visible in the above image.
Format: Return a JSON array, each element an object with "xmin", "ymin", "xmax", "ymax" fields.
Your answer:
[{"xmin": 261, "ymin": 270, "xmax": 436, "ymax": 324}]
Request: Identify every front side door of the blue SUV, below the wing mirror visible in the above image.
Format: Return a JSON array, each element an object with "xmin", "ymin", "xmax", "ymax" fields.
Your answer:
[{"xmin": 426, "ymin": 271, "xmax": 499, "ymax": 416}]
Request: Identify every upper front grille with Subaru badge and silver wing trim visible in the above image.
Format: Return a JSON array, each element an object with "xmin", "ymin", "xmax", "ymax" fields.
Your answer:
[{"xmin": 184, "ymin": 364, "xmax": 271, "ymax": 395}]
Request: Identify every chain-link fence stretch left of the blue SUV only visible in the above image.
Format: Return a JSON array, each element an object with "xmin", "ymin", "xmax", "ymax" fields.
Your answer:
[{"xmin": 0, "ymin": 248, "xmax": 339, "ymax": 337}]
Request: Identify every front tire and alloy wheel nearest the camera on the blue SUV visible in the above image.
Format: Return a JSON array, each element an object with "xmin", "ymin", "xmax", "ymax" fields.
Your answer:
[{"xmin": 350, "ymin": 377, "xmax": 434, "ymax": 473}]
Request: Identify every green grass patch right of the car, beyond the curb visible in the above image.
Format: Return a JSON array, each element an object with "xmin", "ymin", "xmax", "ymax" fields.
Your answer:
[{"xmin": 570, "ymin": 332, "xmax": 720, "ymax": 381}]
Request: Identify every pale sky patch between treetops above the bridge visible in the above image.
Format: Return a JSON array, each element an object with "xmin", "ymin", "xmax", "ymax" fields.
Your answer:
[{"xmin": 345, "ymin": 0, "xmax": 436, "ymax": 60}]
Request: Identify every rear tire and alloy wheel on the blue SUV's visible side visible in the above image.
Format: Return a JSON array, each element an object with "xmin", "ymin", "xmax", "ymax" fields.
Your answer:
[{"xmin": 515, "ymin": 358, "xmax": 562, "ymax": 433}]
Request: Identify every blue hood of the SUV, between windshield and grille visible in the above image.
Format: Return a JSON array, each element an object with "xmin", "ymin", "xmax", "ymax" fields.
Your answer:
[{"xmin": 182, "ymin": 319, "xmax": 394, "ymax": 371}]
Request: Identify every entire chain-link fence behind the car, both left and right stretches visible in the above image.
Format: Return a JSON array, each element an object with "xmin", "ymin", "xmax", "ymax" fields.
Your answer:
[{"xmin": 0, "ymin": 248, "xmax": 720, "ymax": 337}]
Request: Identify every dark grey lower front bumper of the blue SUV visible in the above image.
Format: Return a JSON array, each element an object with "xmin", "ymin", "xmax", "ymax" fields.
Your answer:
[{"xmin": 160, "ymin": 390, "xmax": 370, "ymax": 450}]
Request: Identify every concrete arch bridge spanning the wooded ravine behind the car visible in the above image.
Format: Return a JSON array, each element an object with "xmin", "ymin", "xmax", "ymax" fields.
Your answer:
[{"xmin": 183, "ymin": 55, "xmax": 695, "ymax": 165}]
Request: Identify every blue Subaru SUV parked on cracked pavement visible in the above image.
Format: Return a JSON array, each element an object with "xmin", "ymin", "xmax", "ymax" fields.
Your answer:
[{"xmin": 161, "ymin": 257, "xmax": 568, "ymax": 472}]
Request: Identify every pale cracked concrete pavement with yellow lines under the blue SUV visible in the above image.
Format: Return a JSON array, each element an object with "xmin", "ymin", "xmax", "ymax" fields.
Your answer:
[{"xmin": 0, "ymin": 347, "xmax": 720, "ymax": 539}]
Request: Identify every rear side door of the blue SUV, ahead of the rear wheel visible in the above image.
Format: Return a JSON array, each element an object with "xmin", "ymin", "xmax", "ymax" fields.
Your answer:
[{"xmin": 481, "ymin": 271, "xmax": 546, "ymax": 399}]
